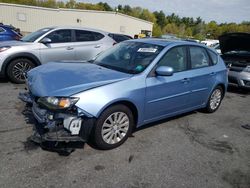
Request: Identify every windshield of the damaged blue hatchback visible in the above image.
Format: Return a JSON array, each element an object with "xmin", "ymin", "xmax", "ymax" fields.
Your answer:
[{"xmin": 94, "ymin": 41, "xmax": 163, "ymax": 74}]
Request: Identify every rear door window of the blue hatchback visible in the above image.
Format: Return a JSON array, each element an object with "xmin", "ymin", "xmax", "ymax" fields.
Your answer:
[{"xmin": 189, "ymin": 46, "xmax": 209, "ymax": 69}]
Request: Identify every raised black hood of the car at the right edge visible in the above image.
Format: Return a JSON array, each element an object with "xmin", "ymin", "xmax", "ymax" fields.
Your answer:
[{"xmin": 219, "ymin": 33, "xmax": 250, "ymax": 54}]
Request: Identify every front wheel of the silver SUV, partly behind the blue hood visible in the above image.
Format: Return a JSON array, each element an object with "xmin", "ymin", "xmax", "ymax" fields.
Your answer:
[{"xmin": 7, "ymin": 58, "xmax": 35, "ymax": 84}]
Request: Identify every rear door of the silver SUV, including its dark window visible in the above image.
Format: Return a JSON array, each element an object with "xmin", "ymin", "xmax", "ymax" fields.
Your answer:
[{"xmin": 74, "ymin": 30, "xmax": 105, "ymax": 60}]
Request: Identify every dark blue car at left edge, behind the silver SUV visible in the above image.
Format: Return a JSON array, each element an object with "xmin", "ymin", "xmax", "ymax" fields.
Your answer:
[{"xmin": 0, "ymin": 24, "xmax": 22, "ymax": 41}]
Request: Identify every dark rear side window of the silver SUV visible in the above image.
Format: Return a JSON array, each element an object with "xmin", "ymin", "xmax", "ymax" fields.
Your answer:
[{"xmin": 75, "ymin": 30, "xmax": 104, "ymax": 42}]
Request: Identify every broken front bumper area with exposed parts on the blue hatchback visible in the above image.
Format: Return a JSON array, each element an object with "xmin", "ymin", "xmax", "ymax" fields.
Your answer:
[{"xmin": 19, "ymin": 93, "xmax": 95, "ymax": 143}]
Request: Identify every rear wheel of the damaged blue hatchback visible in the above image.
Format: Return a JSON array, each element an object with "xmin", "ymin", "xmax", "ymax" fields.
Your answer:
[{"xmin": 206, "ymin": 86, "xmax": 223, "ymax": 113}]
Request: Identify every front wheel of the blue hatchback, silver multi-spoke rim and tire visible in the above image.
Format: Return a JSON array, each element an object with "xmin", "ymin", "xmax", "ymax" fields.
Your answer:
[{"xmin": 94, "ymin": 105, "xmax": 134, "ymax": 149}]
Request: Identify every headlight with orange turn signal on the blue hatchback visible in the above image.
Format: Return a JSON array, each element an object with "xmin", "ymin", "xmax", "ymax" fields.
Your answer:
[{"xmin": 37, "ymin": 97, "xmax": 79, "ymax": 110}]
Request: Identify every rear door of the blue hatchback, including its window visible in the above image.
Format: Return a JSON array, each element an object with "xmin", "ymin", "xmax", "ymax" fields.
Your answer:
[{"xmin": 189, "ymin": 46, "xmax": 216, "ymax": 107}]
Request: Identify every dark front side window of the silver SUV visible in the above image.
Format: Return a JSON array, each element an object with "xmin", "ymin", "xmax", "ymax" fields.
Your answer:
[{"xmin": 46, "ymin": 29, "xmax": 72, "ymax": 43}]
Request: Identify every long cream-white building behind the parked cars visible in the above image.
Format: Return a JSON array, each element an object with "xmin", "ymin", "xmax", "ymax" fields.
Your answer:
[{"xmin": 0, "ymin": 3, "xmax": 153, "ymax": 36}]
